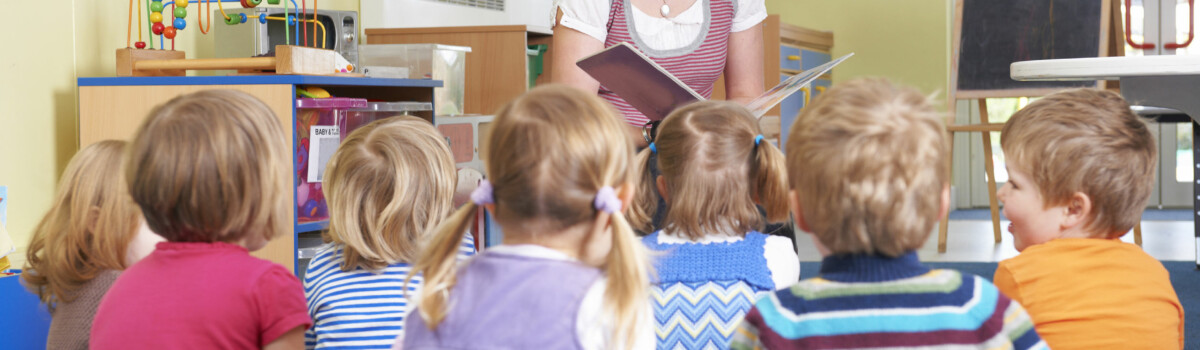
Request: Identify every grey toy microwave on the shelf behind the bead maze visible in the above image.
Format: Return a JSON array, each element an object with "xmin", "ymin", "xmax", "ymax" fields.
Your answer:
[{"xmin": 212, "ymin": 7, "xmax": 359, "ymax": 67}]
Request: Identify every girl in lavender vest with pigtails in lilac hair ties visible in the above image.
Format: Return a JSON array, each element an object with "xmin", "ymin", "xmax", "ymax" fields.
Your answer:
[{"xmin": 403, "ymin": 86, "xmax": 654, "ymax": 350}]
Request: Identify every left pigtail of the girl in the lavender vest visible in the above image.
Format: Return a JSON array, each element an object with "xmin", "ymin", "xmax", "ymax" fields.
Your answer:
[{"xmin": 404, "ymin": 203, "xmax": 479, "ymax": 330}]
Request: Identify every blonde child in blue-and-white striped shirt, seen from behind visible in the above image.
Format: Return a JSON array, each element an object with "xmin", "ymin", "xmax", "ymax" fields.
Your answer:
[{"xmin": 304, "ymin": 116, "xmax": 475, "ymax": 349}]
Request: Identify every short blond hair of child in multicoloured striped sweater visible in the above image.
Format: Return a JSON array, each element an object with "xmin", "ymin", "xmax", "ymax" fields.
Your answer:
[{"xmin": 787, "ymin": 79, "xmax": 949, "ymax": 257}]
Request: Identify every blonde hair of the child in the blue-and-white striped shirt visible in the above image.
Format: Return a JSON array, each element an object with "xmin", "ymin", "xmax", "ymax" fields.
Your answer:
[{"xmin": 324, "ymin": 116, "xmax": 458, "ymax": 271}]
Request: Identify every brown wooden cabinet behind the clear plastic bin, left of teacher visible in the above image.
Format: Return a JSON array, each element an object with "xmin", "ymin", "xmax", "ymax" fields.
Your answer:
[{"xmin": 366, "ymin": 25, "xmax": 552, "ymax": 114}]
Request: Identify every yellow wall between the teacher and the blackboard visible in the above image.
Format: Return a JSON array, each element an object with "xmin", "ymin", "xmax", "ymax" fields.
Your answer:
[{"xmin": 767, "ymin": 0, "xmax": 952, "ymax": 101}]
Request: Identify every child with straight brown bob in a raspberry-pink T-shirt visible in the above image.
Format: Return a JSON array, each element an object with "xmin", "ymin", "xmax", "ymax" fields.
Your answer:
[{"xmin": 91, "ymin": 90, "xmax": 311, "ymax": 349}]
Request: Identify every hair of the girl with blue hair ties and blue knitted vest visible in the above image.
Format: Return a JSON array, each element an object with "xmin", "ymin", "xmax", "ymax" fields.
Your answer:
[{"xmin": 630, "ymin": 101, "xmax": 787, "ymax": 239}]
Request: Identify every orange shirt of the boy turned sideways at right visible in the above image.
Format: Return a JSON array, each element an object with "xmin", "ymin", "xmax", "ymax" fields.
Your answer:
[{"xmin": 994, "ymin": 239, "xmax": 1183, "ymax": 350}]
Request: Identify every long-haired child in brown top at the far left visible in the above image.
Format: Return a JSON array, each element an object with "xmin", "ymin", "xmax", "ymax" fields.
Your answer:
[{"xmin": 22, "ymin": 140, "xmax": 152, "ymax": 349}]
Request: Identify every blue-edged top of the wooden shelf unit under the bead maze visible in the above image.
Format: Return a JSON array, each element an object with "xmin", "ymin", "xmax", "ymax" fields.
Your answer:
[{"xmin": 79, "ymin": 76, "xmax": 442, "ymax": 88}]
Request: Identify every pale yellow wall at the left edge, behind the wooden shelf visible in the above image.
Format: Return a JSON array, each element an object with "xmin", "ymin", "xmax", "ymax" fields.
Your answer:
[{"xmin": 0, "ymin": 0, "xmax": 359, "ymax": 267}]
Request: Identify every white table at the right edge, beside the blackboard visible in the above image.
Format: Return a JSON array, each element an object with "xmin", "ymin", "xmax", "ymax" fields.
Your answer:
[{"xmin": 1010, "ymin": 55, "xmax": 1200, "ymax": 268}]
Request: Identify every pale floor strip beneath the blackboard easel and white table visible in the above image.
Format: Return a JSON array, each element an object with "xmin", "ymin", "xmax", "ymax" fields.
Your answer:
[{"xmin": 797, "ymin": 210, "xmax": 1196, "ymax": 263}]
